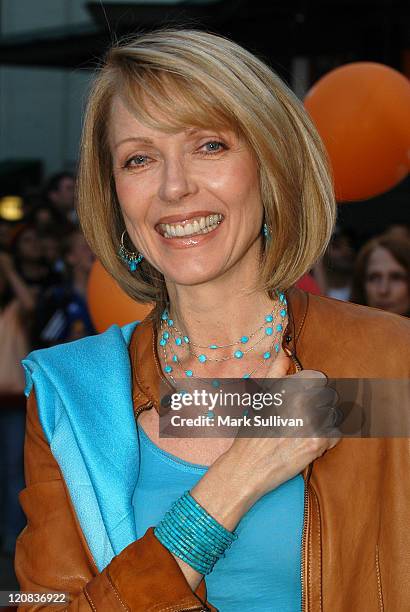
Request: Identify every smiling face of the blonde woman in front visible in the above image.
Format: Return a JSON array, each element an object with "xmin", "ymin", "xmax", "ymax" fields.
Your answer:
[{"xmin": 110, "ymin": 99, "xmax": 263, "ymax": 285}]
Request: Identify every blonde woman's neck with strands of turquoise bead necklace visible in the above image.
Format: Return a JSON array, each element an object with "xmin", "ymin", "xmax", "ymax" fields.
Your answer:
[{"xmin": 157, "ymin": 245, "xmax": 287, "ymax": 380}]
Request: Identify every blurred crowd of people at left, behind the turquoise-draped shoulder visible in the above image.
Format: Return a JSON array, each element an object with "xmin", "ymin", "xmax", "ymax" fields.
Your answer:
[{"xmin": 0, "ymin": 172, "xmax": 95, "ymax": 556}]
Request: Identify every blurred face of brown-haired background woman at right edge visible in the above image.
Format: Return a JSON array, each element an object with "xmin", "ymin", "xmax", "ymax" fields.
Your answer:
[{"xmin": 365, "ymin": 246, "xmax": 410, "ymax": 315}]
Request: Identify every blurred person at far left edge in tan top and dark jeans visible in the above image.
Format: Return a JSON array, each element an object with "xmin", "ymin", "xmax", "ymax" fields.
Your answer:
[{"xmin": 0, "ymin": 251, "xmax": 35, "ymax": 555}]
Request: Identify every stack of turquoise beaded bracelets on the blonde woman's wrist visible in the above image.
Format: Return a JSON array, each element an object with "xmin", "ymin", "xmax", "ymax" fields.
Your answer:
[{"xmin": 154, "ymin": 491, "xmax": 238, "ymax": 575}]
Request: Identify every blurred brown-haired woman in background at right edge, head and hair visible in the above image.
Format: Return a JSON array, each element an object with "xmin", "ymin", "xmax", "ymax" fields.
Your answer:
[{"xmin": 351, "ymin": 235, "xmax": 410, "ymax": 317}]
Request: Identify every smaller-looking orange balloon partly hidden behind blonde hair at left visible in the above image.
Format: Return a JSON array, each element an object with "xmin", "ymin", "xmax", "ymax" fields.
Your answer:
[{"xmin": 87, "ymin": 260, "xmax": 153, "ymax": 332}]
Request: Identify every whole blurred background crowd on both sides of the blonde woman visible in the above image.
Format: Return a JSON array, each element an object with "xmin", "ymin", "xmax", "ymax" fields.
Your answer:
[{"xmin": 0, "ymin": 172, "xmax": 410, "ymax": 568}]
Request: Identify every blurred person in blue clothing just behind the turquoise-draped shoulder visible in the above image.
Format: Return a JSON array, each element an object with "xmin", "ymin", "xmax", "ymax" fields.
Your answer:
[{"xmin": 34, "ymin": 231, "xmax": 95, "ymax": 347}]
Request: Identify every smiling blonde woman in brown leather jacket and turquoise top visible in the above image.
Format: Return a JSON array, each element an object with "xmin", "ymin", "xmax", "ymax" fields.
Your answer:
[{"xmin": 16, "ymin": 30, "xmax": 410, "ymax": 612}]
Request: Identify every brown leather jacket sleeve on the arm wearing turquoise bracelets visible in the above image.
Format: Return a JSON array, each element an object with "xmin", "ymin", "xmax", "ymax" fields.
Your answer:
[{"xmin": 15, "ymin": 392, "xmax": 217, "ymax": 612}]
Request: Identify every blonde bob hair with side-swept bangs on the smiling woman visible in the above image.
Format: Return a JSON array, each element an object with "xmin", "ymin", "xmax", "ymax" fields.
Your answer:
[{"xmin": 78, "ymin": 29, "xmax": 336, "ymax": 316}]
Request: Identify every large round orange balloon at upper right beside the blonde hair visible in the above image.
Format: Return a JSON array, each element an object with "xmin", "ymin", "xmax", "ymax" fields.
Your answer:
[{"xmin": 305, "ymin": 62, "xmax": 410, "ymax": 201}]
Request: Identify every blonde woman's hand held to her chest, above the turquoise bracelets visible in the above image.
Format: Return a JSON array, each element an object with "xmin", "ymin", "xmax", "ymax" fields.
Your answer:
[{"xmin": 191, "ymin": 353, "xmax": 340, "ymax": 530}]
